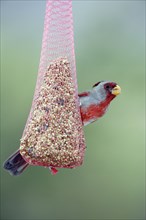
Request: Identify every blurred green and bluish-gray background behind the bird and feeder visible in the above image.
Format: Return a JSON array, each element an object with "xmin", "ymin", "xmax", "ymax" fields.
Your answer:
[{"xmin": 1, "ymin": 0, "xmax": 145, "ymax": 220}]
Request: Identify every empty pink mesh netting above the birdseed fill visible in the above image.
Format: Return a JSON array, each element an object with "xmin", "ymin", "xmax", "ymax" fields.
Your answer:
[{"xmin": 23, "ymin": 0, "xmax": 79, "ymax": 132}]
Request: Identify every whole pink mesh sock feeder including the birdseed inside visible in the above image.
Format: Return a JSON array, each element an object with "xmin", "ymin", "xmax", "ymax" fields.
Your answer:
[{"xmin": 20, "ymin": 0, "xmax": 85, "ymax": 168}]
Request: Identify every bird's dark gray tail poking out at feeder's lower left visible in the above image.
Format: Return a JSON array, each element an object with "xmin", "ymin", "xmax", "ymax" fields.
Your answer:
[{"xmin": 4, "ymin": 150, "xmax": 28, "ymax": 176}]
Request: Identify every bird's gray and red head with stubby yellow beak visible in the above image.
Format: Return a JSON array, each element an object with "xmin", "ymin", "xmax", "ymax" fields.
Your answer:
[{"xmin": 93, "ymin": 81, "xmax": 121, "ymax": 101}]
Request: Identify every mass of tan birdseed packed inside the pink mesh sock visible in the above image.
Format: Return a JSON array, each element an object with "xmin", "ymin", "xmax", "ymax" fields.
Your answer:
[{"xmin": 20, "ymin": 58, "xmax": 85, "ymax": 168}]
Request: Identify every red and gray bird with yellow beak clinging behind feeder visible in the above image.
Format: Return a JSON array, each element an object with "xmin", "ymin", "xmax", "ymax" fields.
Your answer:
[{"xmin": 4, "ymin": 81, "xmax": 121, "ymax": 176}]
